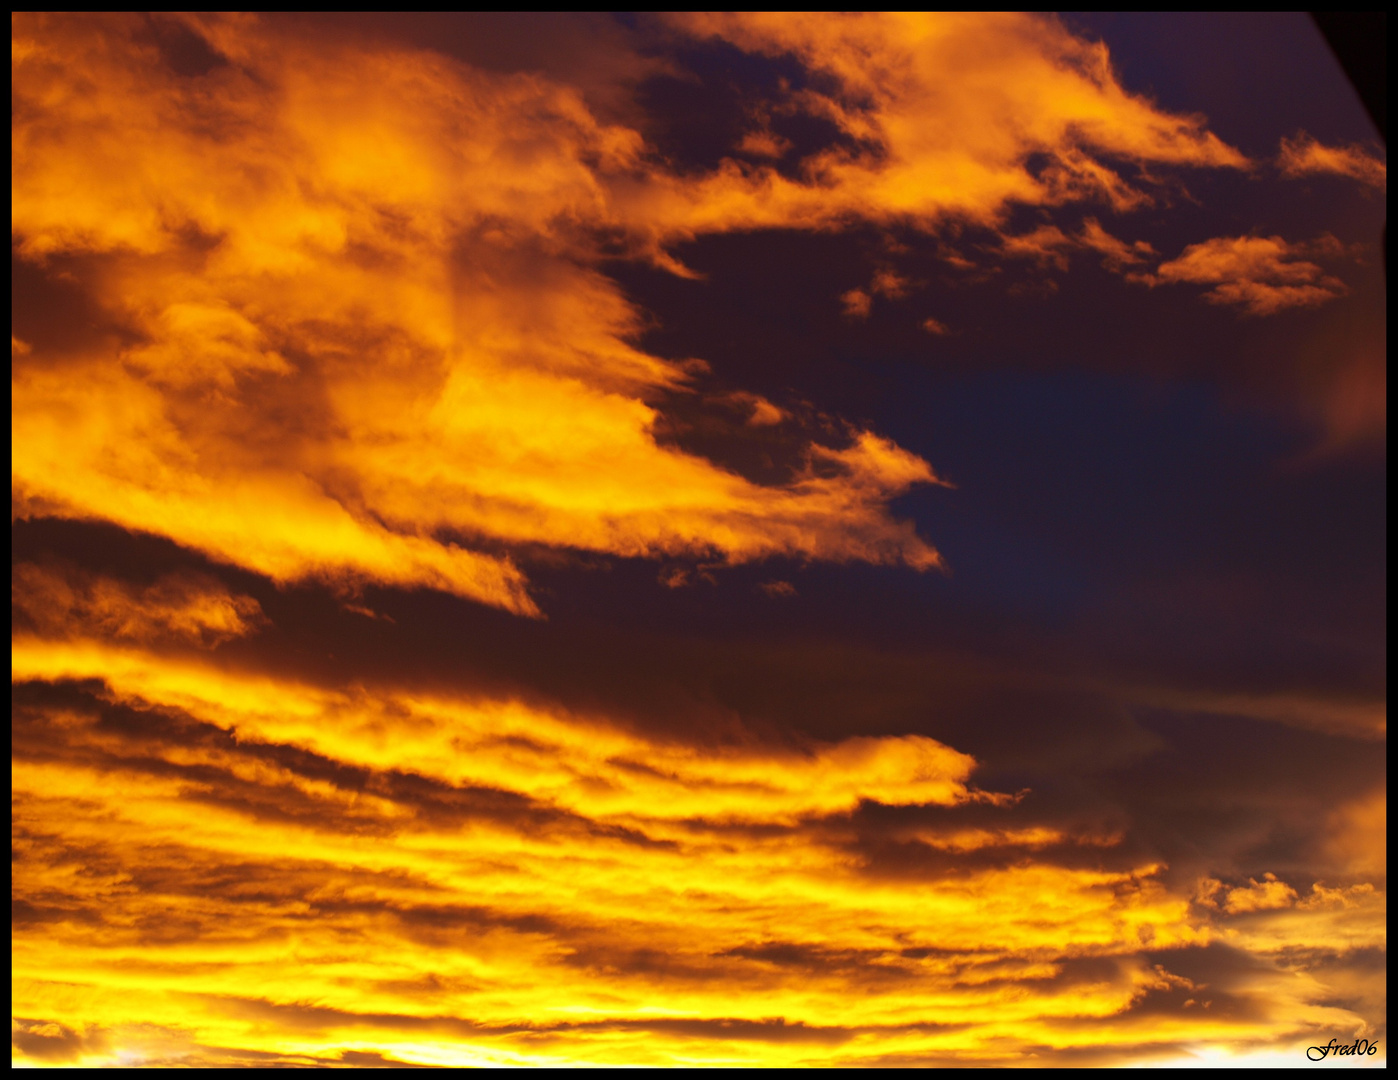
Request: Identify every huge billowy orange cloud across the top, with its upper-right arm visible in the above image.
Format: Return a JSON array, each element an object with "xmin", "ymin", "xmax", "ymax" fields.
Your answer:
[{"xmin": 11, "ymin": 15, "xmax": 1280, "ymax": 615}]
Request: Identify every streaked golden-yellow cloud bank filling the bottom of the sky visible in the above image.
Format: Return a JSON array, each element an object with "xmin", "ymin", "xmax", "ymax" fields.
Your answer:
[{"xmin": 13, "ymin": 636, "xmax": 1383, "ymax": 1065}]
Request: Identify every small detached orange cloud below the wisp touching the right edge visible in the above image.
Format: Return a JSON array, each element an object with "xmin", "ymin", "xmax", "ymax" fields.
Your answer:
[{"xmin": 1127, "ymin": 236, "xmax": 1346, "ymax": 314}]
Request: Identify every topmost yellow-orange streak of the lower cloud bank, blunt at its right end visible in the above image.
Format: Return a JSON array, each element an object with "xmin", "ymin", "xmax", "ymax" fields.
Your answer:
[{"xmin": 14, "ymin": 637, "xmax": 995, "ymax": 823}]
